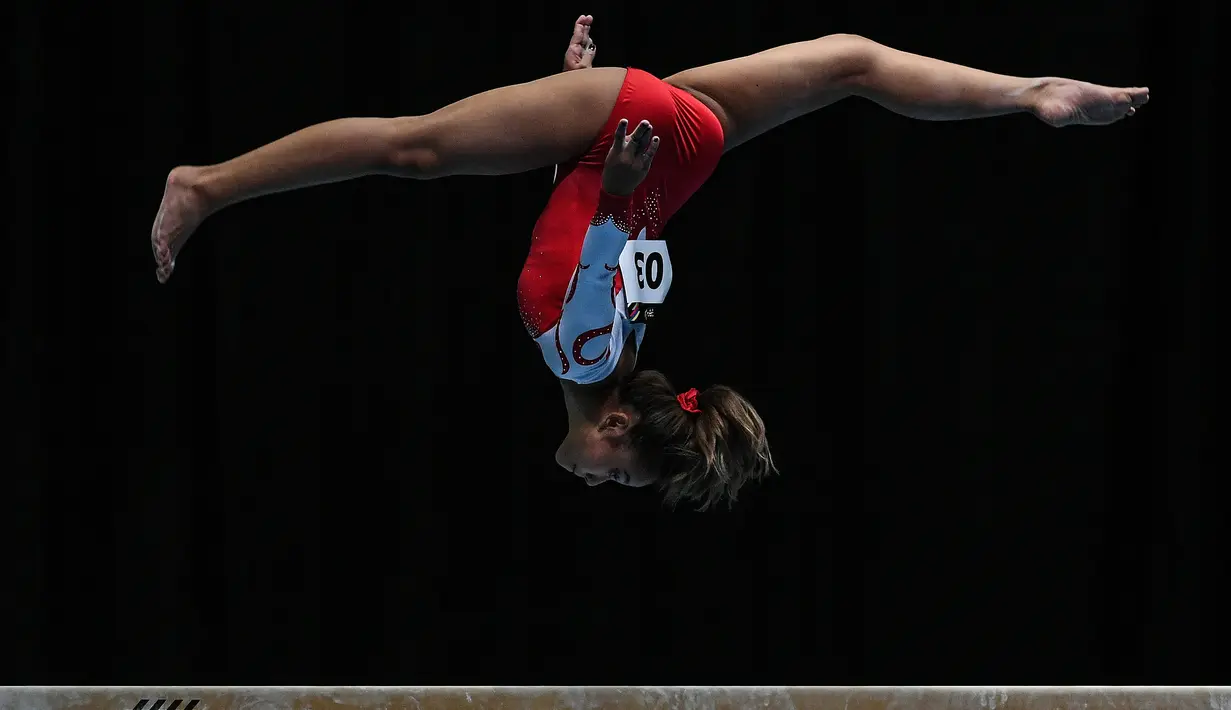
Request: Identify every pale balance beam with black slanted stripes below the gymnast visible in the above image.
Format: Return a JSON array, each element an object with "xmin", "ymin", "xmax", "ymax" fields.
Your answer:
[{"xmin": 0, "ymin": 685, "xmax": 1231, "ymax": 710}]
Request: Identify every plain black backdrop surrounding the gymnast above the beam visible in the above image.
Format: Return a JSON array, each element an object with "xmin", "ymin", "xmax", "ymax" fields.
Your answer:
[{"xmin": 0, "ymin": 0, "xmax": 1229, "ymax": 684}]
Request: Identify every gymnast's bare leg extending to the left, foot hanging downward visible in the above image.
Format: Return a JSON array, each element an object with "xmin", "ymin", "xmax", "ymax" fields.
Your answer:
[{"xmin": 150, "ymin": 68, "xmax": 625, "ymax": 282}]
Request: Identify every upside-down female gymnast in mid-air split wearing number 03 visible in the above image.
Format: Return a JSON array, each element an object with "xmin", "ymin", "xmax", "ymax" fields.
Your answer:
[{"xmin": 150, "ymin": 15, "xmax": 1149, "ymax": 509}]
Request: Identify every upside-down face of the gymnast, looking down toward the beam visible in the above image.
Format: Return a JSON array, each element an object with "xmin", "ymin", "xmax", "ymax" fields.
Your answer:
[{"xmin": 555, "ymin": 411, "xmax": 654, "ymax": 489}]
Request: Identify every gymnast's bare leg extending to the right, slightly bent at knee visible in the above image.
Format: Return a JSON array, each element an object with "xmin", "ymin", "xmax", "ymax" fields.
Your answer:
[{"xmin": 666, "ymin": 34, "xmax": 1150, "ymax": 150}]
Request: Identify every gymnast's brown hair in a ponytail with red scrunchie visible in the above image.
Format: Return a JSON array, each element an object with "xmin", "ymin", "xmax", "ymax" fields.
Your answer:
[{"xmin": 619, "ymin": 370, "xmax": 778, "ymax": 511}]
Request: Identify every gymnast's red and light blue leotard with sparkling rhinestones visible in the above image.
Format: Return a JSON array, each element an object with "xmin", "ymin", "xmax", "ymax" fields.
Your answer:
[{"xmin": 517, "ymin": 69, "xmax": 724, "ymax": 383}]
